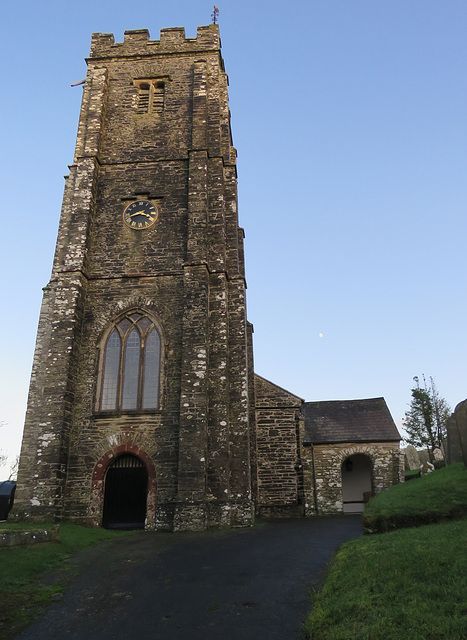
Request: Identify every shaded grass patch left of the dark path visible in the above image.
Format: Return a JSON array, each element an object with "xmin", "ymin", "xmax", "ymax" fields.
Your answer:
[{"xmin": 0, "ymin": 523, "xmax": 130, "ymax": 640}]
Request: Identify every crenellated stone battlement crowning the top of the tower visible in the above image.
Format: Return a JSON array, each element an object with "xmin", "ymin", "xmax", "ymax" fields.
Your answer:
[{"xmin": 90, "ymin": 24, "xmax": 221, "ymax": 58}]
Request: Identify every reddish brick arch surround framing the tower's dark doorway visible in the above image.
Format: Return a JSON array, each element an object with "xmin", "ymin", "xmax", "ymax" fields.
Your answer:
[{"xmin": 88, "ymin": 444, "xmax": 156, "ymax": 529}]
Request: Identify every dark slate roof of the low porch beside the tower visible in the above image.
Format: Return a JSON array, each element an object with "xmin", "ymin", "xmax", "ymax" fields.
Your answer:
[{"xmin": 302, "ymin": 398, "xmax": 401, "ymax": 444}]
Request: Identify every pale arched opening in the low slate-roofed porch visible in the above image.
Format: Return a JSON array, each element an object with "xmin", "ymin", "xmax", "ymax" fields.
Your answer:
[{"xmin": 342, "ymin": 453, "xmax": 373, "ymax": 513}]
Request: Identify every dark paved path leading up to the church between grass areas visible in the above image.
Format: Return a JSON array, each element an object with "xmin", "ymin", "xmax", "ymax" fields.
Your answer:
[{"xmin": 19, "ymin": 516, "xmax": 362, "ymax": 640}]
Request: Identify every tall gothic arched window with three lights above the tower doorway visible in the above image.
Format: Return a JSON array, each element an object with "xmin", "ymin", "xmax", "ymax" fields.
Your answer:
[{"xmin": 99, "ymin": 312, "xmax": 161, "ymax": 411}]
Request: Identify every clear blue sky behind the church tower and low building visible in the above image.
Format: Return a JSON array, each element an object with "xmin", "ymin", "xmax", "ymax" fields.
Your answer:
[{"xmin": 0, "ymin": 0, "xmax": 467, "ymax": 479}]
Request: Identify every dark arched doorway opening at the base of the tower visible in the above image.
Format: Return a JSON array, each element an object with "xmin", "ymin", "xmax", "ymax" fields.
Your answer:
[{"xmin": 102, "ymin": 453, "xmax": 148, "ymax": 529}]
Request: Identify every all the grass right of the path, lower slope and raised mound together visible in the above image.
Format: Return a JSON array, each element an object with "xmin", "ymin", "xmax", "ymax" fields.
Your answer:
[{"xmin": 305, "ymin": 464, "xmax": 467, "ymax": 640}]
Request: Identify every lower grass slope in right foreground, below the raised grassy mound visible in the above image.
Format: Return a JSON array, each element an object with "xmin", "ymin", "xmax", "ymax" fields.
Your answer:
[{"xmin": 306, "ymin": 520, "xmax": 467, "ymax": 640}]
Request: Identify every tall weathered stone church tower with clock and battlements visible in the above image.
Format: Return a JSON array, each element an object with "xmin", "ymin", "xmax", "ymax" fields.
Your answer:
[{"xmin": 15, "ymin": 25, "xmax": 254, "ymax": 530}]
